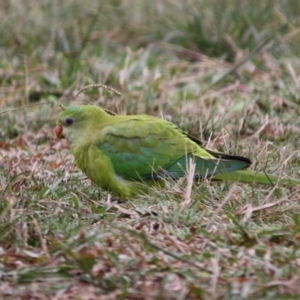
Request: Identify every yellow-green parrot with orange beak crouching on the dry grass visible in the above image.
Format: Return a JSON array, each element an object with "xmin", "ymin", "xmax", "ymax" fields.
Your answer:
[{"xmin": 55, "ymin": 105, "xmax": 300, "ymax": 198}]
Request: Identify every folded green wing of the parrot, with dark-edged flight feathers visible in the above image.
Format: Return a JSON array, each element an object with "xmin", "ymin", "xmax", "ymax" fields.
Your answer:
[{"xmin": 98, "ymin": 116, "xmax": 251, "ymax": 180}]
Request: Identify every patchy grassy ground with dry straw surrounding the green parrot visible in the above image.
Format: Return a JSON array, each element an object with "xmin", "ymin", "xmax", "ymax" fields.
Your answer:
[{"xmin": 0, "ymin": 0, "xmax": 300, "ymax": 299}]
